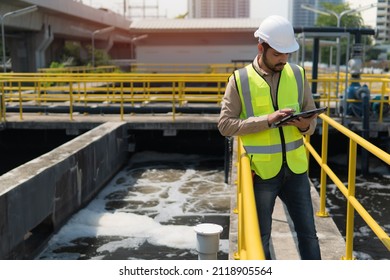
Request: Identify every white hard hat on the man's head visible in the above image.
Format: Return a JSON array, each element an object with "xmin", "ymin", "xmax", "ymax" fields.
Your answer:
[{"xmin": 254, "ymin": 15, "xmax": 299, "ymax": 53}]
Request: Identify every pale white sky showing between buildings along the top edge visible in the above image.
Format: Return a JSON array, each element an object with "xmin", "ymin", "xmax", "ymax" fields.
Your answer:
[{"xmin": 82, "ymin": 0, "xmax": 377, "ymax": 27}]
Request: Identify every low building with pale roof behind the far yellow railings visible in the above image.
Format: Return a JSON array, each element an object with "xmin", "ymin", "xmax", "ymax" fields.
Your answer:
[{"xmin": 130, "ymin": 18, "xmax": 262, "ymax": 65}]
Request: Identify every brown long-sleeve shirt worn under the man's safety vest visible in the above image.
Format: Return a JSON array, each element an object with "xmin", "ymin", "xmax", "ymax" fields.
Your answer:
[{"xmin": 218, "ymin": 56, "xmax": 317, "ymax": 136}]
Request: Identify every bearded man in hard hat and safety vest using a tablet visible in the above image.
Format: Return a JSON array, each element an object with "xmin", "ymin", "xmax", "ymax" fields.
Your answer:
[{"xmin": 218, "ymin": 16, "xmax": 321, "ymax": 259}]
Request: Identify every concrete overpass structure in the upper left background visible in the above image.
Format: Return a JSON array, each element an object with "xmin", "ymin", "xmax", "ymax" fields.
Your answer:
[{"xmin": 0, "ymin": 0, "xmax": 133, "ymax": 72}]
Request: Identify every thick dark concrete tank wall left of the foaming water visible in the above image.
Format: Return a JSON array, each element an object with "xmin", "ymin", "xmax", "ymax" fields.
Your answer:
[{"xmin": 0, "ymin": 122, "xmax": 128, "ymax": 259}]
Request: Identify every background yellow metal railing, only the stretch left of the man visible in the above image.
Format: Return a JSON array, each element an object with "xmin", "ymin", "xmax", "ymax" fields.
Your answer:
[{"xmin": 0, "ymin": 73, "xmax": 227, "ymax": 120}]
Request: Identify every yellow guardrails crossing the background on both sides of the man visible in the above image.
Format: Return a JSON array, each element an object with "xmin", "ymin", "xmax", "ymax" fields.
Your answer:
[{"xmin": 0, "ymin": 70, "xmax": 390, "ymax": 123}]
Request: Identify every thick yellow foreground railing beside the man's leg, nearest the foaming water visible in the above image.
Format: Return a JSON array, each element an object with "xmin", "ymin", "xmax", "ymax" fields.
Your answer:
[{"xmin": 234, "ymin": 137, "xmax": 265, "ymax": 260}]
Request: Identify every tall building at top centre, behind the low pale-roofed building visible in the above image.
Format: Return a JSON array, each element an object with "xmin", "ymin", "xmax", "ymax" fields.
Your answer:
[{"xmin": 188, "ymin": 0, "xmax": 250, "ymax": 18}]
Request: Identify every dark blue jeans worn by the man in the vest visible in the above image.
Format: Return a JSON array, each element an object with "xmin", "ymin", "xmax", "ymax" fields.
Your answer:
[{"xmin": 254, "ymin": 165, "xmax": 321, "ymax": 260}]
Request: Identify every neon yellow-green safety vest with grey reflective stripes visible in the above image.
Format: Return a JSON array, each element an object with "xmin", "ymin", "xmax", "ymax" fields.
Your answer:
[{"xmin": 233, "ymin": 63, "xmax": 308, "ymax": 179}]
